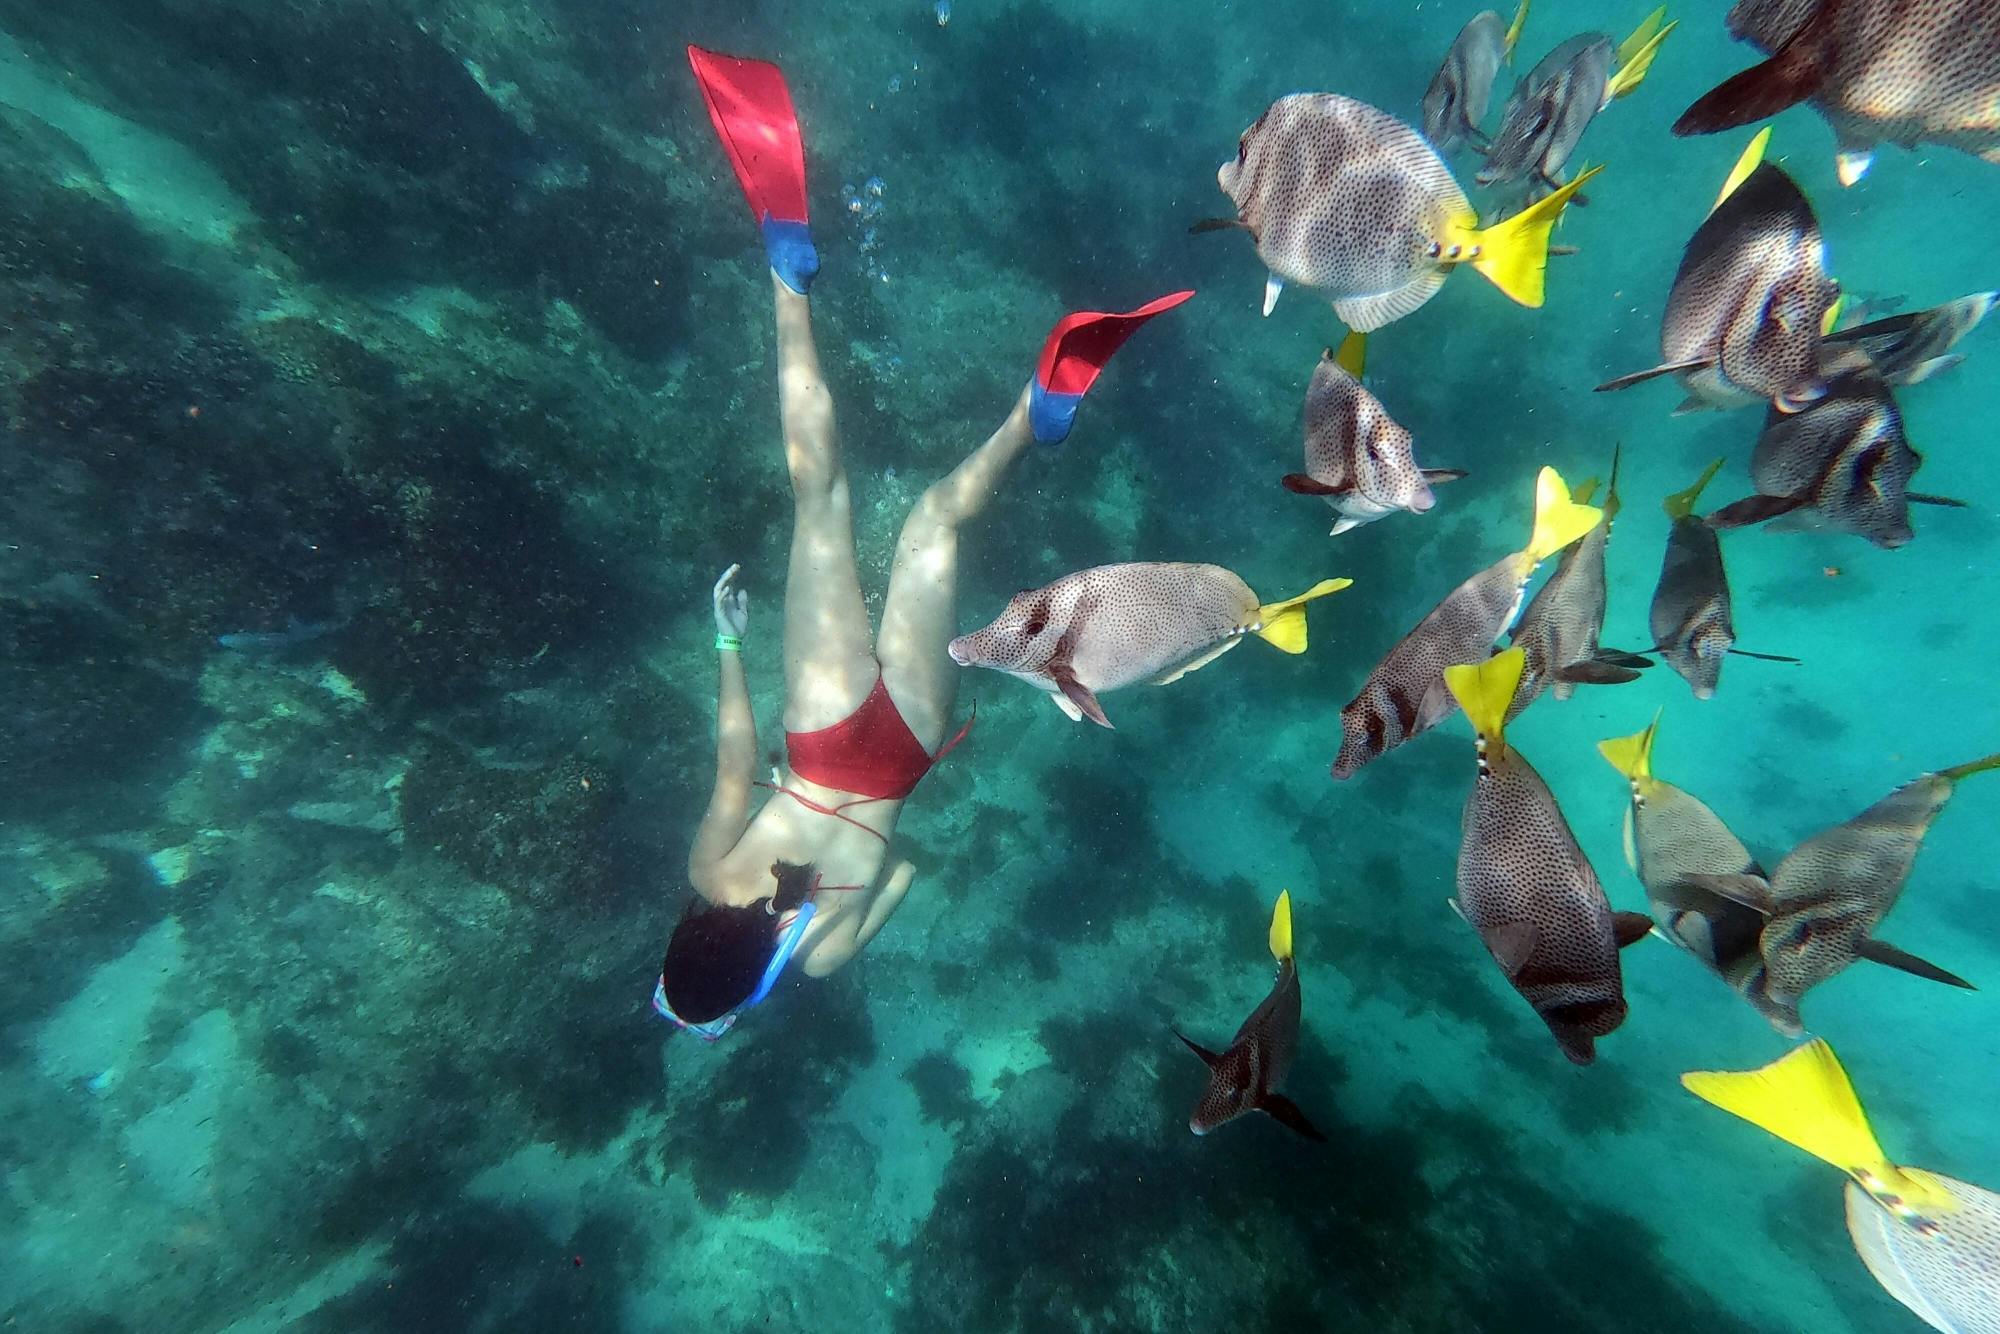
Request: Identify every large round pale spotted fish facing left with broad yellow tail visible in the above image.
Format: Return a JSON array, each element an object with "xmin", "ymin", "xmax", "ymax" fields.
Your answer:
[{"xmin": 1194, "ymin": 92, "xmax": 1592, "ymax": 332}]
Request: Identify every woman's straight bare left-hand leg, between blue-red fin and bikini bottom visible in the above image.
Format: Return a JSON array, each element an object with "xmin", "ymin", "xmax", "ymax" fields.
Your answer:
[{"xmin": 770, "ymin": 274, "xmax": 876, "ymax": 732}]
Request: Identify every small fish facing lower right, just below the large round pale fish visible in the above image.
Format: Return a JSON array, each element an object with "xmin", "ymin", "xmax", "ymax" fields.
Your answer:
[{"xmin": 1284, "ymin": 334, "xmax": 1466, "ymax": 538}]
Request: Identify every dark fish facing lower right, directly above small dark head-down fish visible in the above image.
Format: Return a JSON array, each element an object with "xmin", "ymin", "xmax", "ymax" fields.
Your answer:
[{"xmin": 1708, "ymin": 358, "xmax": 1964, "ymax": 548}]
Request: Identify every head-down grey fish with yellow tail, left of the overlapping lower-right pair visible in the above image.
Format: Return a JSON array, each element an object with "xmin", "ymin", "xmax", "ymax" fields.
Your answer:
[{"xmin": 1598, "ymin": 718, "xmax": 1764, "ymax": 996}]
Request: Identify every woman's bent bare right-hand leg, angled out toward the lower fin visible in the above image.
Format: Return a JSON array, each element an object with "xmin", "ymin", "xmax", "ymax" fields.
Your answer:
[{"xmin": 876, "ymin": 392, "xmax": 1034, "ymax": 750}]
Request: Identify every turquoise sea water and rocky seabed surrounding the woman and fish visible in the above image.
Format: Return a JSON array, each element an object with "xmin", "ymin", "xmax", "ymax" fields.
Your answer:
[{"xmin": 0, "ymin": 0, "xmax": 2000, "ymax": 1334}]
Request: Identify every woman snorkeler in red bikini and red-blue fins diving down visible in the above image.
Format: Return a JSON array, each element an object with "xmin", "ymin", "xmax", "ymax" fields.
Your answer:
[{"xmin": 654, "ymin": 46, "xmax": 1192, "ymax": 1040}]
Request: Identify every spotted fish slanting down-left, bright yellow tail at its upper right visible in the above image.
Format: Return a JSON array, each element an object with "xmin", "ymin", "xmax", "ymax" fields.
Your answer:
[{"xmin": 1334, "ymin": 468, "xmax": 1604, "ymax": 778}]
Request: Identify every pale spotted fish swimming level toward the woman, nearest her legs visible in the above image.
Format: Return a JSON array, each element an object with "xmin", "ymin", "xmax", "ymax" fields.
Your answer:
[{"xmin": 948, "ymin": 562, "xmax": 1354, "ymax": 728}]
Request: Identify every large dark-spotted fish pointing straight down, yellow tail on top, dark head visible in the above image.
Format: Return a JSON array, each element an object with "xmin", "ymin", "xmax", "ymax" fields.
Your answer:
[{"xmin": 1444, "ymin": 648, "xmax": 1652, "ymax": 1066}]
